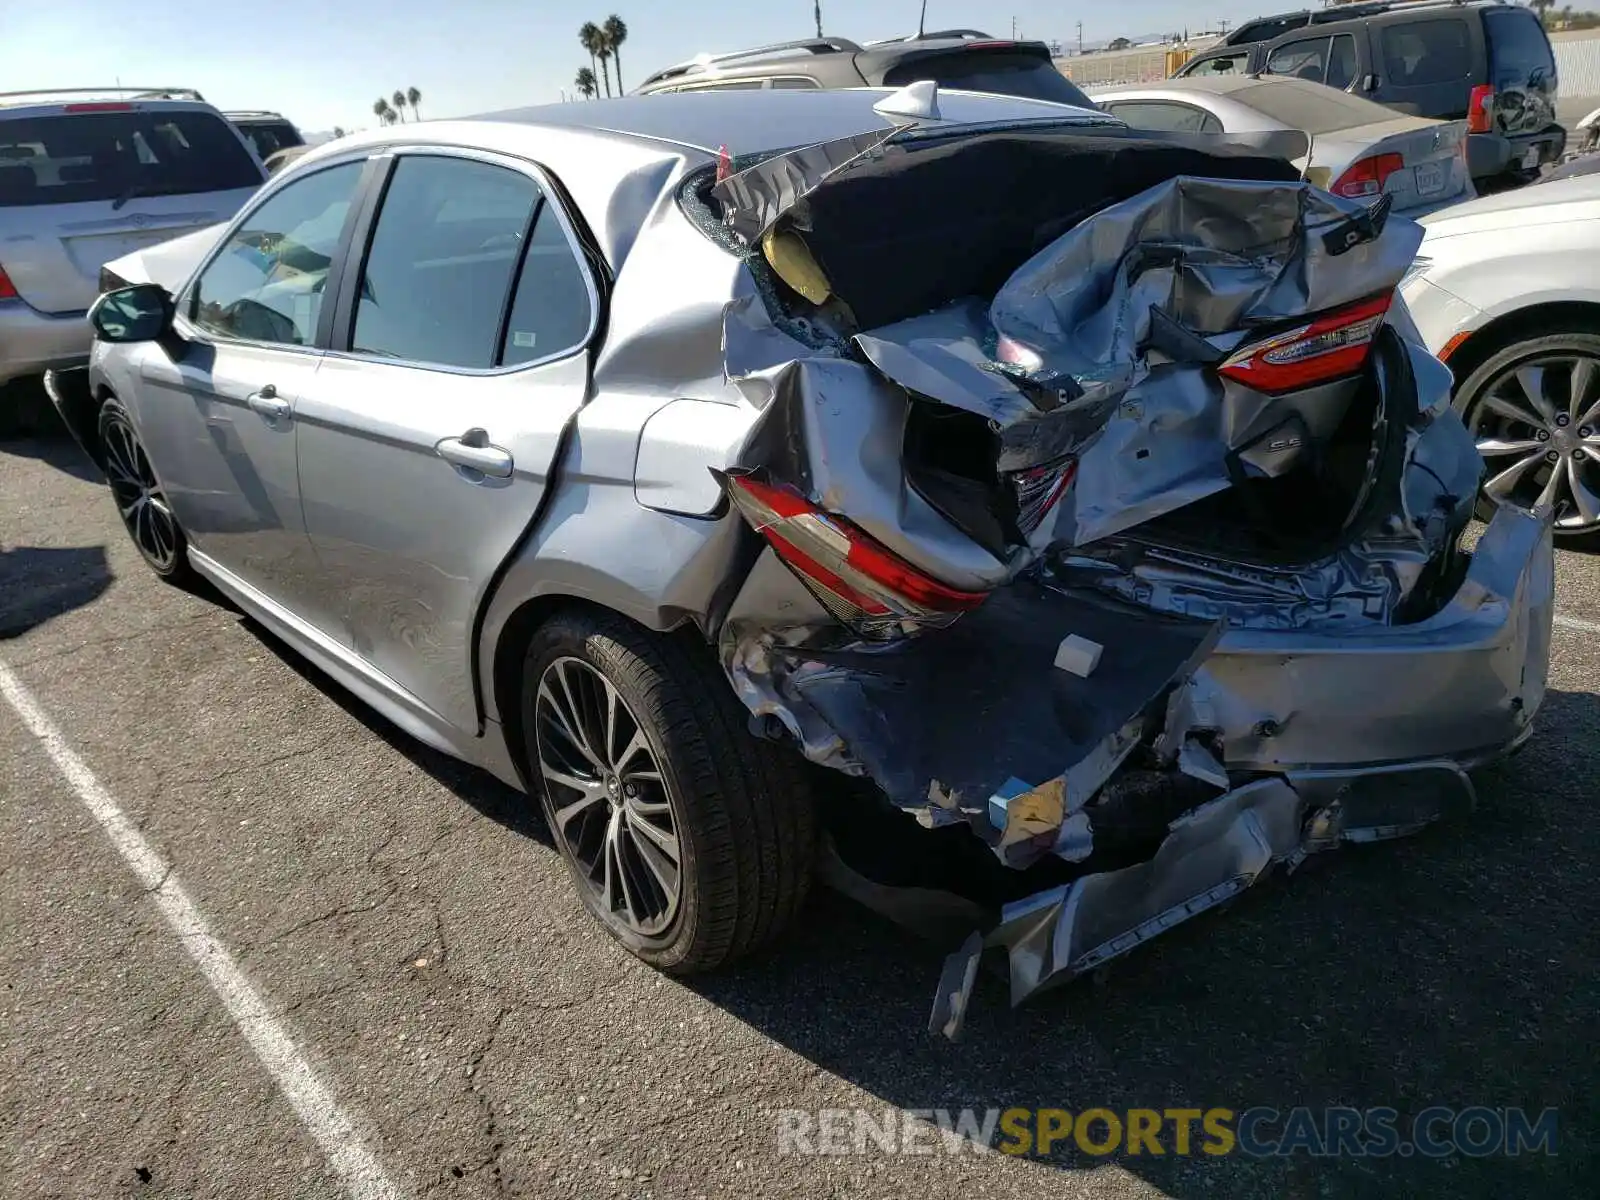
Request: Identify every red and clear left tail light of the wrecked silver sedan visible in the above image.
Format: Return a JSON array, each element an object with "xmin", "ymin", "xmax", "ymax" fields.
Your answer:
[{"xmin": 722, "ymin": 474, "xmax": 989, "ymax": 638}]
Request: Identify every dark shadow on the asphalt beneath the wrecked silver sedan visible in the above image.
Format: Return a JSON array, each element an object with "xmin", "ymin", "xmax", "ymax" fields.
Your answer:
[{"xmin": 219, "ymin": 604, "xmax": 1600, "ymax": 1197}]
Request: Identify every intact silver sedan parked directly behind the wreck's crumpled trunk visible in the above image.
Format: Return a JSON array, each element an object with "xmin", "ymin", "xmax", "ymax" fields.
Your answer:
[{"xmin": 1094, "ymin": 75, "xmax": 1474, "ymax": 216}]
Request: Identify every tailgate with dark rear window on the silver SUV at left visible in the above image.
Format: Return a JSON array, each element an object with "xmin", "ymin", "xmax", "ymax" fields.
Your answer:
[{"xmin": 0, "ymin": 102, "xmax": 262, "ymax": 314}]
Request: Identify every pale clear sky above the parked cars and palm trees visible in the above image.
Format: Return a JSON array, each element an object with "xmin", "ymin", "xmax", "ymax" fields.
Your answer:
[{"xmin": 0, "ymin": 0, "xmax": 1273, "ymax": 131}]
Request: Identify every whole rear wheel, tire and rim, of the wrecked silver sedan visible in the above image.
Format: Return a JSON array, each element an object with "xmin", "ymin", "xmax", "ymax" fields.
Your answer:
[{"xmin": 522, "ymin": 608, "xmax": 816, "ymax": 974}]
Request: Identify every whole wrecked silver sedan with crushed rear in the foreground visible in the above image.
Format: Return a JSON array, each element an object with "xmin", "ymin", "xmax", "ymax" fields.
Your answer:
[{"xmin": 51, "ymin": 85, "xmax": 1554, "ymax": 1035}]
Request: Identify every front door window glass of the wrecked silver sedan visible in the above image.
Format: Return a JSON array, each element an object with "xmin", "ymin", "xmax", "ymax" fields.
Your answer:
[{"xmin": 189, "ymin": 162, "xmax": 365, "ymax": 346}]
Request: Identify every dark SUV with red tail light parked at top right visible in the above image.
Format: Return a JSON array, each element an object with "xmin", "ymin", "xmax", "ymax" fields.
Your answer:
[{"xmin": 1178, "ymin": 0, "xmax": 1566, "ymax": 190}]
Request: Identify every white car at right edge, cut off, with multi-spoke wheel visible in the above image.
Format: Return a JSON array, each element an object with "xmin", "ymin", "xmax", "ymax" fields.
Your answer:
[{"xmin": 1402, "ymin": 174, "xmax": 1600, "ymax": 539}]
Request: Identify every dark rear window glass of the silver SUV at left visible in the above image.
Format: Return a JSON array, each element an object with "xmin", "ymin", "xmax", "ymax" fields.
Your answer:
[{"xmin": 0, "ymin": 110, "xmax": 261, "ymax": 206}]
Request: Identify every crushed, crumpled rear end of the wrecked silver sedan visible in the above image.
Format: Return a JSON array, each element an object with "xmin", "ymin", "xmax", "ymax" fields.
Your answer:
[{"xmin": 685, "ymin": 122, "xmax": 1554, "ymax": 1035}]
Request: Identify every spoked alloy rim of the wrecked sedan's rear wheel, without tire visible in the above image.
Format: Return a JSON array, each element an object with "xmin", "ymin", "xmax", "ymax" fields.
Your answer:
[{"xmin": 534, "ymin": 658, "xmax": 683, "ymax": 938}]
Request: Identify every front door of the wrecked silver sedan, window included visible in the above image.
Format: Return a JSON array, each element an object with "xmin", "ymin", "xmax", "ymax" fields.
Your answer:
[{"xmin": 136, "ymin": 162, "xmax": 363, "ymax": 620}]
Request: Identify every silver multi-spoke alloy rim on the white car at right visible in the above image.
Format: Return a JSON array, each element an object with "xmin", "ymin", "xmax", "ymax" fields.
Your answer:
[{"xmin": 1469, "ymin": 354, "xmax": 1600, "ymax": 534}]
